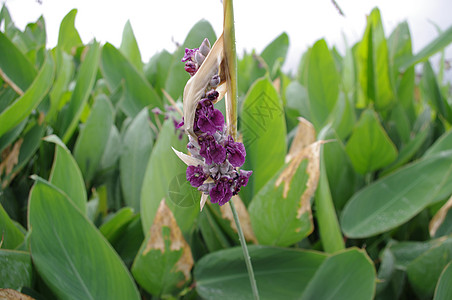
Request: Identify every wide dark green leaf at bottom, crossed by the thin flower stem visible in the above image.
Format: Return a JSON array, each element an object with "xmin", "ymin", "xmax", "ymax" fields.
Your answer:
[{"xmin": 194, "ymin": 245, "xmax": 326, "ymax": 300}]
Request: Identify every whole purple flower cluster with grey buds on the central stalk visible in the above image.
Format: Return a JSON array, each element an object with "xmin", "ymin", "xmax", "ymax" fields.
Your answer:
[{"xmin": 182, "ymin": 39, "xmax": 253, "ymax": 205}]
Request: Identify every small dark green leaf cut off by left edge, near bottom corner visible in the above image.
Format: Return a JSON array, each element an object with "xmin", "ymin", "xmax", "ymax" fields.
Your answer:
[{"xmin": 0, "ymin": 249, "xmax": 33, "ymax": 290}]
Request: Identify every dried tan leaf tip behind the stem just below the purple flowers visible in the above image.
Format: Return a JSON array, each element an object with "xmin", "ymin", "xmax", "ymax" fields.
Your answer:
[{"xmin": 220, "ymin": 195, "xmax": 258, "ymax": 244}]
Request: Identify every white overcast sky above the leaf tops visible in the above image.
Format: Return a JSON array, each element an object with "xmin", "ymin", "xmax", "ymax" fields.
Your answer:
[{"xmin": 0, "ymin": 0, "xmax": 452, "ymax": 70}]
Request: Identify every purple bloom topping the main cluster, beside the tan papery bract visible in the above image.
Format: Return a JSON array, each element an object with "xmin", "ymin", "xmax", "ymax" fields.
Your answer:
[{"xmin": 196, "ymin": 98, "xmax": 224, "ymax": 134}]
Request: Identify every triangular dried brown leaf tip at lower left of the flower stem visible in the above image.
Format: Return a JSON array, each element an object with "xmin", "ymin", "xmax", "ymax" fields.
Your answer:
[{"xmin": 143, "ymin": 199, "xmax": 193, "ymax": 280}]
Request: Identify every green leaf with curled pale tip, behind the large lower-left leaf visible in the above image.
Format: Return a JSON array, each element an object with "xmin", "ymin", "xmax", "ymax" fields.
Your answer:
[{"xmin": 44, "ymin": 135, "xmax": 87, "ymax": 213}]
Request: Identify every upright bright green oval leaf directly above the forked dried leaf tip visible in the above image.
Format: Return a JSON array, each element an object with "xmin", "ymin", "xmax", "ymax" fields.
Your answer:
[{"xmin": 307, "ymin": 40, "xmax": 340, "ymax": 130}]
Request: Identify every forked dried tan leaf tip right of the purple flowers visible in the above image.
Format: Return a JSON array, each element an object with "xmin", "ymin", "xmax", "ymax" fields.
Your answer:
[{"xmin": 275, "ymin": 118, "xmax": 325, "ymax": 219}]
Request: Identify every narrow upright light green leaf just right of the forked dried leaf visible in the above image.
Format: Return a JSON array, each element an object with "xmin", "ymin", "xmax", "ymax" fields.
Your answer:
[{"xmin": 314, "ymin": 145, "xmax": 345, "ymax": 253}]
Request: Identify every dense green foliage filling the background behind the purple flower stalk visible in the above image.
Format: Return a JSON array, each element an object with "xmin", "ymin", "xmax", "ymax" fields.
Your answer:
[{"xmin": 0, "ymin": 7, "xmax": 452, "ymax": 300}]
